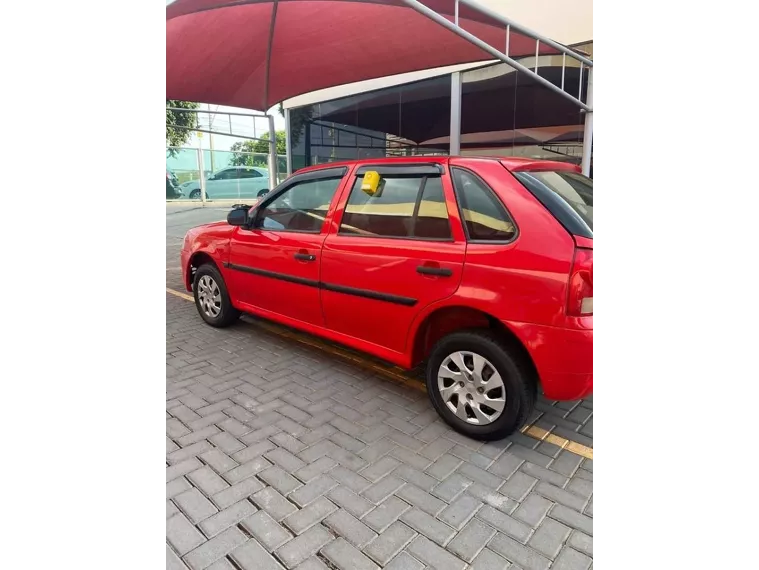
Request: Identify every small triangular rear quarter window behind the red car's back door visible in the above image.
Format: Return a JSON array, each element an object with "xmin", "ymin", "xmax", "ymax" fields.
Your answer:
[{"xmin": 451, "ymin": 168, "xmax": 517, "ymax": 242}]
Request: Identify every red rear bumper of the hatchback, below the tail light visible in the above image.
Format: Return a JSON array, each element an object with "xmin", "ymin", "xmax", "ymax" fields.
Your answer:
[{"xmin": 504, "ymin": 322, "xmax": 594, "ymax": 400}]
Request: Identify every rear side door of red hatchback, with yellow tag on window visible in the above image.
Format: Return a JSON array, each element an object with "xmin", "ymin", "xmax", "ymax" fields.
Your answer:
[{"xmin": 321, "ymin": 162, "xmax": 466, "ymax": 353}]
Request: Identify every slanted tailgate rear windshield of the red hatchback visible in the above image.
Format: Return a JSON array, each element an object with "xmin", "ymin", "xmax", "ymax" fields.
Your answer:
[{"xmin": 512, "ymin": 171, "xmax": 593, "ymax": 239}]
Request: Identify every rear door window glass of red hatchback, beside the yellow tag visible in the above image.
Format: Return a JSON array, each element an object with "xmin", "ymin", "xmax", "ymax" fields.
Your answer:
[{"xmin": 340, "ymin": 176, "xmax": 452, "ymax": 240}]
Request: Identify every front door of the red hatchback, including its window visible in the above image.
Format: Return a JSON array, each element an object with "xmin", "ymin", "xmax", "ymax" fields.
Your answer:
[{"xmin": 227, "ymin": 167, "xmax": 348, "ymax": 326}]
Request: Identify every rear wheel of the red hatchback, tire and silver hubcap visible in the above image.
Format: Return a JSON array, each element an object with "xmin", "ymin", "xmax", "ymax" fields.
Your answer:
[{"xmin": 427, "ymin": 330, "xmax": 537, "ymax": 440}]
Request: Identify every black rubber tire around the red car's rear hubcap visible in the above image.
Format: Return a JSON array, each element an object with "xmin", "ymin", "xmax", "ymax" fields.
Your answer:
[{"xmin": 426, "ymin": 329, "xmax": 537, "ymax": 441}]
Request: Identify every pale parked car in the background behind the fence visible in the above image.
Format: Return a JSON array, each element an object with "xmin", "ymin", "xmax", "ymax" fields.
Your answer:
[{"xmin": 180, "ymin": 166, "xmax": 269, "ymax": 200}]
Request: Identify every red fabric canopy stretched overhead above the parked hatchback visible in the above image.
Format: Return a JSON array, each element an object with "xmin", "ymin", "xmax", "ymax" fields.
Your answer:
[{"xmin": 166, "ymin": 0, "xmax": 556, "ymax": 111}]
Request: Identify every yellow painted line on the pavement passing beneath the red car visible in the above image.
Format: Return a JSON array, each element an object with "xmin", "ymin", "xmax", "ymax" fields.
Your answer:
[{"xmin": 166, "ymin": 287, "xmax": 593, "ymax": 459}]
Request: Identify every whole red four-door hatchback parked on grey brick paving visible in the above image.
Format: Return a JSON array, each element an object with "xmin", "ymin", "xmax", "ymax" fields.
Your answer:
[{"xmin": 181, "ymin": 157, "xmax": 593, "ymax": 439}]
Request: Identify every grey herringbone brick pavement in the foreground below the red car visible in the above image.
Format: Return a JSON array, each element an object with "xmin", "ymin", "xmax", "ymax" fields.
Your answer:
[{"xmin": 161, "ymin": 295, "xmax": 598, "ymax": 570}]
